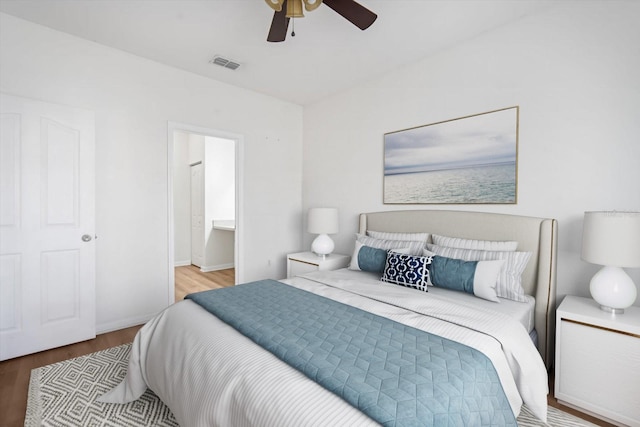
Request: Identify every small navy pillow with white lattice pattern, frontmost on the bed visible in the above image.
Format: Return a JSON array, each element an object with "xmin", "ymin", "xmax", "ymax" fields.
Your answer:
[{"xmin": 380, "ymin": 251, "xmax": 432, "ymax": 292}]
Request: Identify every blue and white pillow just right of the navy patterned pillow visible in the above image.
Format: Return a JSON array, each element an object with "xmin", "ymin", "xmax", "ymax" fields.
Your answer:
[{"xmin": 429, "ymin": 256, "xmax": 504, "ymax": 302}]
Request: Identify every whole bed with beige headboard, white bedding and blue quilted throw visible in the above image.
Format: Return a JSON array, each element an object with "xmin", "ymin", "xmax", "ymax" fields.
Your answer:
[{"xmin": 101, "ymin": 210, "xmax": 557, "ymax": 426}]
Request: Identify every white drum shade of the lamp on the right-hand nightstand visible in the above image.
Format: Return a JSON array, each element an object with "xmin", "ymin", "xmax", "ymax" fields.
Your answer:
[{"xmin": 582, "ymin": 211, "xmax": 640, "ymax": 267}]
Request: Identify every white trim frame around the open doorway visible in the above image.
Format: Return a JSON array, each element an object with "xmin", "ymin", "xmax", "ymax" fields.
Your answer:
[{"xmin": 167, "ymin": 121, "xmax": 244, "ymax": 305}]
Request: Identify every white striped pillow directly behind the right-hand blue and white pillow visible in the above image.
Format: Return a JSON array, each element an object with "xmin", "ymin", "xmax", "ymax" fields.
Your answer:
[{"xmin": 424, "ymin": 243, "xmax": 532, "ymax": 302}]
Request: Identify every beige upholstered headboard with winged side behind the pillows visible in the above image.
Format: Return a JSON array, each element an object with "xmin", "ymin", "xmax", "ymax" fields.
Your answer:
[{"xmin": 359, "ymin": 210, "xmax": 558, "ymax": 369}]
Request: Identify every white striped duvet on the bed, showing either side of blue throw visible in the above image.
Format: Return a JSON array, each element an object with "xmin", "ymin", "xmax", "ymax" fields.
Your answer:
[{"xmin": 99, "ymin": 270, "xmax": 548, "ymax": 427}]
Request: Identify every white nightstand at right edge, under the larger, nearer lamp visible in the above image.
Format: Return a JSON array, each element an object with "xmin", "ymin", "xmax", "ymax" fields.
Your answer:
[{"xmin": 555, "ymin": 296, "xmax": 640, "ymax": 426}]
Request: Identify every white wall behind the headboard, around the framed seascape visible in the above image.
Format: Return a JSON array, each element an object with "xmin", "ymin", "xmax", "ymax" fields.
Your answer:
[{"xmin": 303, "ymin": 1, "xmax": 640, "ymax": 305}]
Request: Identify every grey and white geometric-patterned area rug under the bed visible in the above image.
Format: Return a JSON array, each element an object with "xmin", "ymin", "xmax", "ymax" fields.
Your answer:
[{"xmin": 24, "ymin": 344, "xmax": 595, "ymax": 427}]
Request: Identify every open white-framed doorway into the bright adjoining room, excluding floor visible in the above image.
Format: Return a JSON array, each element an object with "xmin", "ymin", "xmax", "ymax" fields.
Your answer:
[{"xmin": 168, "ymin": 123, "xmax": 243, "ymax": 304}]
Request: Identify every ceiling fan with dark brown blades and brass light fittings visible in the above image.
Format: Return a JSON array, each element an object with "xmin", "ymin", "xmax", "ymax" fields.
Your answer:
[{"xmin": 265, "ymin": 0, "xmax": 378, "ymax": 42}]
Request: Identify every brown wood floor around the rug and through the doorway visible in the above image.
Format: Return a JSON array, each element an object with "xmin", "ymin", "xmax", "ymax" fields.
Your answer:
[{"xmin": 0, "ymin": 266, "xmax": 613, "ymax": 427}]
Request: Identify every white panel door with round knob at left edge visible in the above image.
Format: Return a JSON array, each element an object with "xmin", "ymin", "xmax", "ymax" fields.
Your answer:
[{"xmin": 0, "ymin": 94, "xmax": 95, "ymax": 360}]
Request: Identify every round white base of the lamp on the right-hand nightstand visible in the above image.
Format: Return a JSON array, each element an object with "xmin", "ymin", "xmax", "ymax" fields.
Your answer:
[{"xmin": 589, "ymin": 266, "xmax": 638, "ymax": 314}]
